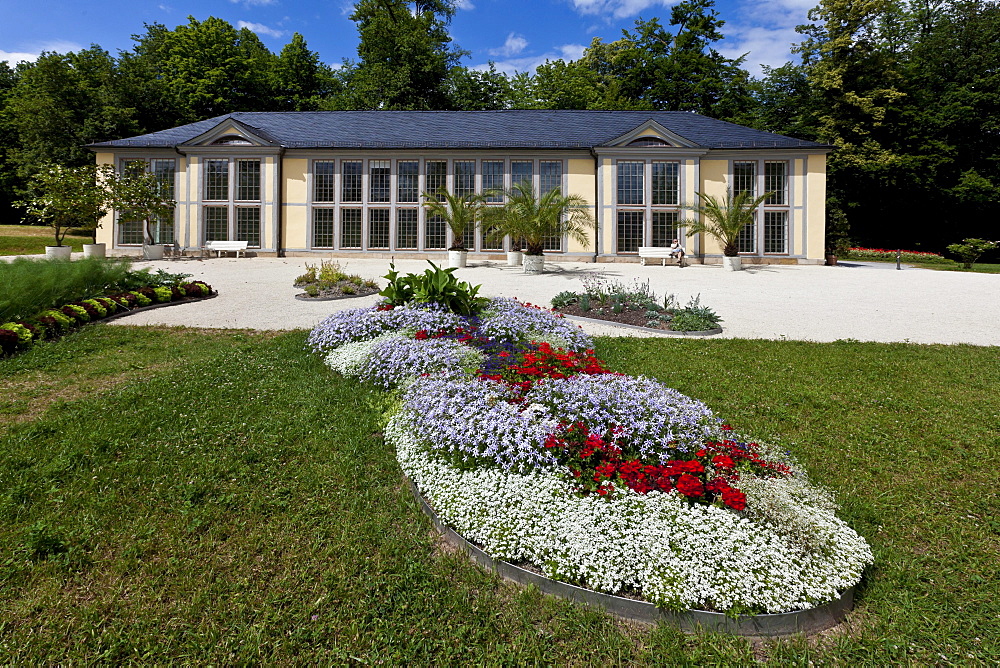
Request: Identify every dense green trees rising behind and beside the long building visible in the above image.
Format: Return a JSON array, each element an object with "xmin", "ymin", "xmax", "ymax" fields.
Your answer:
[{"xmin": 0, "ymin": 0, "xmax": 1000, "ymax": 251}]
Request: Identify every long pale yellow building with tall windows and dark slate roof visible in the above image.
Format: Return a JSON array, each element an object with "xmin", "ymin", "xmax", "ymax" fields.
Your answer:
[{"xmin": 90, "ymin": 111, "xmax": 830, "ymax": 263}]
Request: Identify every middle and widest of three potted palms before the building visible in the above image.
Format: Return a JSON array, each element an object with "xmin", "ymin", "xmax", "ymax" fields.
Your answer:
[{"xmin": 483, "ymin": 181, "xmax": 594, "ymax": 274}]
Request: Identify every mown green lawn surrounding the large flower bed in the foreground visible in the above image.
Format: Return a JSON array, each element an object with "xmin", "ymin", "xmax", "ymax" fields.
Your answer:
[{"xmin": 0, "ymin": 324, "xmax": 1000, "ymax": 665}]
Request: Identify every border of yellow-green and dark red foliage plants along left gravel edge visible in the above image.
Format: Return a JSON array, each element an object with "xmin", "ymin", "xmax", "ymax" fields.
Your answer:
[{"xmin": 0, "ymin": 281, "xmax": 212, "ymax": 356}]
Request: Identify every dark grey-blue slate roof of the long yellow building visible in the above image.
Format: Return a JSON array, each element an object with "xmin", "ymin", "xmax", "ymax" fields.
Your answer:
[{"xmin": 89, "ymin": 110, "xmax": 829, "ymax": 149}]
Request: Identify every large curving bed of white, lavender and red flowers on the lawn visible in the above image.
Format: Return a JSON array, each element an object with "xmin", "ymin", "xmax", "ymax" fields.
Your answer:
[{"xmin": 309, "ymin": 299, "xmax": 872, "ymax": 613}]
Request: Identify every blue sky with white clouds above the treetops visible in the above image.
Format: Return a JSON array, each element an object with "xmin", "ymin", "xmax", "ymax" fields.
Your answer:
[{"xmin": 0, "ymin": 0, "xmax": 818, "ymax": 74}]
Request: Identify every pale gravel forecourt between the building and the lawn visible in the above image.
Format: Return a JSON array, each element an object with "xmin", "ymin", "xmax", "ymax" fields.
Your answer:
[{"xmin": 103, "ymin": 258, "xmax": 1000, "ymax": 346}]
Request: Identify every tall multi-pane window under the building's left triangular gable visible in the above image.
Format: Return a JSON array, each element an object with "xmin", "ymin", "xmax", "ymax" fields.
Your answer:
[{"xmin": 202, "ymin": 158, "xmax": 262, "ymax": 248}]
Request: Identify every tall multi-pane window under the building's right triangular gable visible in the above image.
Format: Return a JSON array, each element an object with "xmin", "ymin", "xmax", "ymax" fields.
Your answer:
[{"xmin": 615, "ymin": 160, "xmax": 683, "ymax": 254}]
